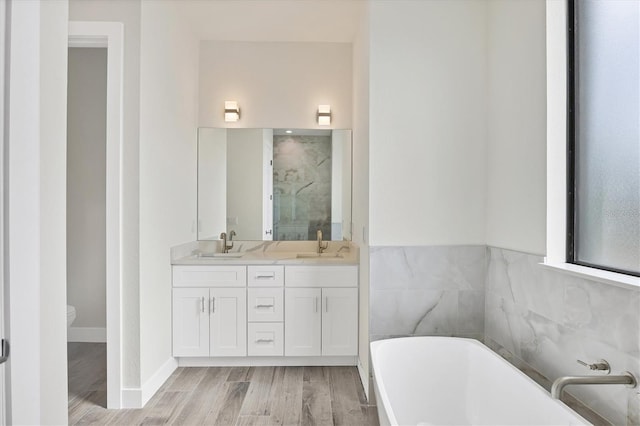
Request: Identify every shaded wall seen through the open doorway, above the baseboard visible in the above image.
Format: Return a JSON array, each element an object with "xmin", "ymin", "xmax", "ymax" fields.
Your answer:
[{"xmin": 67, "ymin": 48, "xmax": 107, "ymax": 332}]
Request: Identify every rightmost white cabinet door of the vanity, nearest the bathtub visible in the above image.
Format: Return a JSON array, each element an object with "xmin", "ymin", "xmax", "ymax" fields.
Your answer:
[{"xmin": 322, "ymin": 288, "xmax": 358, "ymax": 356}]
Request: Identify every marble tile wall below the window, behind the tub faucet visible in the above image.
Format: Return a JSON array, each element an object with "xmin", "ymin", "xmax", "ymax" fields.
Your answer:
[{"xmin": 485, "ymin": 247, "xmax": 640, "ymax": 425}]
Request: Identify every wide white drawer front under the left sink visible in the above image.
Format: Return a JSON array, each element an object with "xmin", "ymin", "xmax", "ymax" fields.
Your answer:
[{"xmin": 173, "ymin": 265, "xmax": 247, "ymax": 287}]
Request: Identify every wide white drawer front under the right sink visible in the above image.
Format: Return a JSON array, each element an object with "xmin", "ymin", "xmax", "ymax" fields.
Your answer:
[{"xmin": 284, "ymin": 266, "xmax": 358, "ymax": 287}]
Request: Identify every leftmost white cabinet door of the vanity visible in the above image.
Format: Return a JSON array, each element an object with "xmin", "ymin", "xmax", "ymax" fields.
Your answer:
[{"xmin": 172, "ymin": 288, "xmax": 209, "ymax": 356}]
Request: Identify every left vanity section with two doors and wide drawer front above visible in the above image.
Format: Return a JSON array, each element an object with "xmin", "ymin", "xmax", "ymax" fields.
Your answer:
[{"xmin": 172, "ymin": 266, "xmax": 247, "ymax": 357}]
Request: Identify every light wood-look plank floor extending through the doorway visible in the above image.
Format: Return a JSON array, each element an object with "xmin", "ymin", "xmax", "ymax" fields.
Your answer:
[{"xmin": 68, "ymin": 343, "xmax": 378, "ymax": 426}]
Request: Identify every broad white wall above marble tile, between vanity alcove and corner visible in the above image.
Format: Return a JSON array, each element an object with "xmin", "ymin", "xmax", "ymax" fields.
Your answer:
[{"xmin": 368, "ymin": 0, "xmax": 487, "ymax": 246}]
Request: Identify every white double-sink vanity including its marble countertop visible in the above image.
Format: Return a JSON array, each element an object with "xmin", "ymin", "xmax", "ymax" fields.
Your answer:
[{"xmin": 172, "ymin": 241, "xmax": 358, "ymax": 366}]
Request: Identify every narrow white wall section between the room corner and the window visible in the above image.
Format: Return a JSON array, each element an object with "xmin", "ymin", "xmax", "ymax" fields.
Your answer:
[{"xmin": 486, "ymin": 0, "xmax": 547, "ymax": 254}]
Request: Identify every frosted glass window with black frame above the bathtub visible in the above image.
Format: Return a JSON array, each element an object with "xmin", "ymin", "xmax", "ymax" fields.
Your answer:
[{"xmin": 567, "ymin": 0, "xmax": 640, "ymax": 276}]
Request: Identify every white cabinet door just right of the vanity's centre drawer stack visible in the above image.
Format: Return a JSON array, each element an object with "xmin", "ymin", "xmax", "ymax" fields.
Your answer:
[{"xmin": 284, "ymin": 288, "xmax": 321, "ymax": 356}]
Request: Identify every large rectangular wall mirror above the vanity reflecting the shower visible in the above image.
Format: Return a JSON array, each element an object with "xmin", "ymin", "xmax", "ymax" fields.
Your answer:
[{"xmin": 198, "ymin": 128, "xmax": 352, "ymax": 241}]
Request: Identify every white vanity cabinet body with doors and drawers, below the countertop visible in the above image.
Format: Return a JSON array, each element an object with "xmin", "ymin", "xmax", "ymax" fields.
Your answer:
[{"xmin": 172, "ymin": 265, "xmax": 358, "ymax": 365}]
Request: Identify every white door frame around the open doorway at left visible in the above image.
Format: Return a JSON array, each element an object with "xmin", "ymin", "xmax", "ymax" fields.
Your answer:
[{"xmin": 69, "ymin": 21, "xmax": 124, "ymax": 408}]
